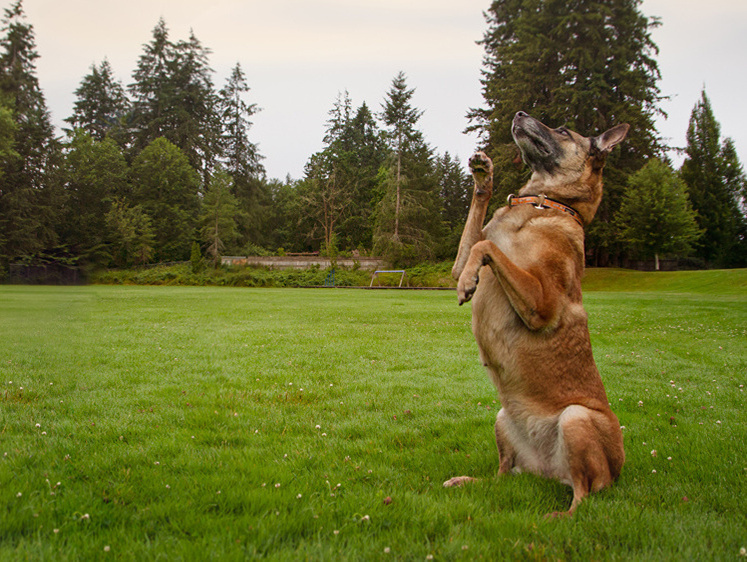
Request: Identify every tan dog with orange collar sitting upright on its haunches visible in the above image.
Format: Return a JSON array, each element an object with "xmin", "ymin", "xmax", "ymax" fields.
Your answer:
[{"xmin": 444, "ymin": 111, "xmax": 629, "ymax": 516}]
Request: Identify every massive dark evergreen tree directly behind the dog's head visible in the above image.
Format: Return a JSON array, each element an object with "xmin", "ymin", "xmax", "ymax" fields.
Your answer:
[{"xmin": 468, "ymin": 0, "xmax": 661, "ymax": 264}]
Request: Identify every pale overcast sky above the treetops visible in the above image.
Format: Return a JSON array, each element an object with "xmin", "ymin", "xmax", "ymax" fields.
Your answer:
[{"xmin": 16, "ymin": 0, "xmax": 747, "ymax": 179}]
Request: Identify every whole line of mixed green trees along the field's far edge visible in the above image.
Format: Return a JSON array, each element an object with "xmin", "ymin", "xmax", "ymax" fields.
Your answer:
[{"xmin": 0, "ymin": 0, "xmax": 747, "ymax": 273}]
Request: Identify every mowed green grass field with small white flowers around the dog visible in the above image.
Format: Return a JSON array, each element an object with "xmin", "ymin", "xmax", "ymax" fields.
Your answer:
[{"xmin": 0, "ymin": 271, "xmax": 747, "ymax": 560}]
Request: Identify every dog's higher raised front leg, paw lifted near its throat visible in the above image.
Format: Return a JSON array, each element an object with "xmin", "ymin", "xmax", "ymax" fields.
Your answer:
[{"xmin": 451, "ymin": 152, "xmax": 493, "ymax": 279}]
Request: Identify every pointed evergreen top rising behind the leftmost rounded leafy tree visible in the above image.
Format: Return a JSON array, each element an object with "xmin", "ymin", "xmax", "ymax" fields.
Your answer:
[{"xmin": 65, "ymin": 59, "xmax": 130, "ymax": 142}]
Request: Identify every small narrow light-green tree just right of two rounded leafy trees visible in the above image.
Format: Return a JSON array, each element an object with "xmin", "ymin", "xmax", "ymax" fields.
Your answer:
[{"xmin": 200, "ymin": 169, "xmax": 239, "ymax": 267}]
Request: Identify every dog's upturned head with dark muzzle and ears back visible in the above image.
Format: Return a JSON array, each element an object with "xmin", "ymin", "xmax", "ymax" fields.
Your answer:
[{"xmin": 511, "ymin": 111, "xmax": 630, "ymax": 224}]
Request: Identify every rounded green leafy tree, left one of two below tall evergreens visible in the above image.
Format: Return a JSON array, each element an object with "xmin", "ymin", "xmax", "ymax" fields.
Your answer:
[{"xmin": 60, "ymin": 129, "xmax": 127, "ymax": 265}]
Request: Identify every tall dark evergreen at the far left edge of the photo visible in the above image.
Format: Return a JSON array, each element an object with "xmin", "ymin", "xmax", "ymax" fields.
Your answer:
[{"xmin": 0, "ymin": 0, "xmax": 60, "ymax": 268}]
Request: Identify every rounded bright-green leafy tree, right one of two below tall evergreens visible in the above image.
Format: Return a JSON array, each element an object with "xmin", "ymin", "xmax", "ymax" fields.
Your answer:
[{"xmin": 130, "ymin": 138, "xmax": 200, "ymax": 261}]
